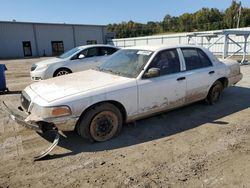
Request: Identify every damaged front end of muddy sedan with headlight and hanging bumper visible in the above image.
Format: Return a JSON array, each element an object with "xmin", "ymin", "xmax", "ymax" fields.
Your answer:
[{"xmin": 3, "ymin": 87, "xmax": 78, "ymax": 160}]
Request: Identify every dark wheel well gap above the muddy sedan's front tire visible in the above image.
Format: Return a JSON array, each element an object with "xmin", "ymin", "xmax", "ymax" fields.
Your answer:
[{"xmin": 76, "ymin": 100, "xmax": 127, "ymax": 127}]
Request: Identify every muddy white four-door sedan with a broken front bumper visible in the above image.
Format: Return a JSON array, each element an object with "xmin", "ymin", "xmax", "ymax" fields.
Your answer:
[{"xmin": 4, "ymin": 46, "xmax": 242, "ymax": 144}]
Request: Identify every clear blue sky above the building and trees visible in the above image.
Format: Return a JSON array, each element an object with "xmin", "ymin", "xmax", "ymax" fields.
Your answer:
[{"xmin": 0, "ymin": 0, "xmax": 250, "ymax": 25}]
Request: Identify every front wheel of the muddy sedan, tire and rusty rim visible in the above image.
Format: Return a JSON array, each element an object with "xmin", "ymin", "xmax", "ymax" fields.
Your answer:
[{"xmin": 76, "ymin": 103, "xmax": 123, "ymax": 142}]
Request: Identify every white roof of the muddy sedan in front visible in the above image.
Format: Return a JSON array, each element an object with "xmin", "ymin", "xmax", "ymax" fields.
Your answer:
[{"xmin": 124, "ymin": 45, "xmax": 205, "ymax": 51}]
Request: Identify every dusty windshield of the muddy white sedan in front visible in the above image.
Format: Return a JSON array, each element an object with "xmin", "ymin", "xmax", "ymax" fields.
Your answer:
[{"xmin": 99, "ymin": 49, "xmax": 153, "ymax": 78}]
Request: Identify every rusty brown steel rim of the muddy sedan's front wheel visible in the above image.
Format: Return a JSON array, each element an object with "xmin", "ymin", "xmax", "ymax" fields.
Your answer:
[{"xmin": 90, "ymin": 111, "xmax": 118, "ymax": 142}]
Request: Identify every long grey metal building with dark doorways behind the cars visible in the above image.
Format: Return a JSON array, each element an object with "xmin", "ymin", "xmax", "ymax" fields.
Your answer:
[{"xmin": 0, "ymin": 21, "xmax": 109, "ymax": 58}]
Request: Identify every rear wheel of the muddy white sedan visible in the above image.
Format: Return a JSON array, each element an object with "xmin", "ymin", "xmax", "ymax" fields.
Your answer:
[{"xmin": 206, "ymin": 81, "xmax": 223, "ymax": 105}]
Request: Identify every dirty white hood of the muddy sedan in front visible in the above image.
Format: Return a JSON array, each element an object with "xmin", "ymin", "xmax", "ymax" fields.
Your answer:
[{"xmin": 30, "ymin": 70, "xmax": 132, "ymax": 102}]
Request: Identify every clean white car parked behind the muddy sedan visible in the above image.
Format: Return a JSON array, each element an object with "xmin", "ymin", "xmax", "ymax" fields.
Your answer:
[{"xmin": 30, "ymin": 44, "xmax": 119, "ymax": 81}]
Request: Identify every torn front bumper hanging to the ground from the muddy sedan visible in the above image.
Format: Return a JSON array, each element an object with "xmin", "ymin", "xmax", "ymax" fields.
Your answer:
[{"xmin": 3, "ymin": 102, "xmax": 60, "ymax": 160}]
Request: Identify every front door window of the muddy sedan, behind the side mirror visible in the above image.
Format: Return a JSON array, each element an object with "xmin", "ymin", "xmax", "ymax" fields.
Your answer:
[{"xmin": 148, "ymin": 49, "xmax": 180, "ymax": 76}]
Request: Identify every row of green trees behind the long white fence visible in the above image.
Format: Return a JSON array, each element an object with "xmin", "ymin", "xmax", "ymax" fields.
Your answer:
[{"xmin": 107, "ymin": 0, "xmax": 250, "ymax": 38}]
